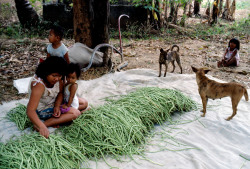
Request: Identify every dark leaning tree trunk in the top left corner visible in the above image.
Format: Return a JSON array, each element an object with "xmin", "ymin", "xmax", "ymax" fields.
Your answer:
[{"xmin": 15, "ymin": 0, "xmax": 39, "ymax": 28}]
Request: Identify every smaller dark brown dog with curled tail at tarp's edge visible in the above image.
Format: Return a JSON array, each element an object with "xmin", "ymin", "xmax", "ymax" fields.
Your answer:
[{"xmin": 159, "ymin": 45, "xmax": 182, "ymax": 77}]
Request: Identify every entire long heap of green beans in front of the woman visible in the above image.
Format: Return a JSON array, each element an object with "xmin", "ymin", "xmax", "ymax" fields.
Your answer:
[{"xmin": 0, "ymin": 87, "xmax": 197, "ymax": 169}]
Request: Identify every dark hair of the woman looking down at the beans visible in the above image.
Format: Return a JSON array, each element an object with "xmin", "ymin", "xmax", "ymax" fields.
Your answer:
[{"xmin": 36, "ymin": 56, "xmax": 67, "ymax": 82}]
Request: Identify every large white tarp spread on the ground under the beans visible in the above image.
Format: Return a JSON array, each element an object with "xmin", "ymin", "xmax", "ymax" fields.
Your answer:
[{"xmin": 0, "ymin": 69, "xmax": 250, "ymax": 169}]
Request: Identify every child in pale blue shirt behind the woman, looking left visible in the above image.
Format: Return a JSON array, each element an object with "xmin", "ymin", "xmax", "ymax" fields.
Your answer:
[{"xmin": 47, "ymin": 26, "xmax": 70, "ymax": 64}]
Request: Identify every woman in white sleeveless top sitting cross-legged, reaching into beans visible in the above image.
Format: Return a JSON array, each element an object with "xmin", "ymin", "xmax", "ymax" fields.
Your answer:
[{"xmin": 26, "ymin": 57, "xmax": 82, "ymax": 138}]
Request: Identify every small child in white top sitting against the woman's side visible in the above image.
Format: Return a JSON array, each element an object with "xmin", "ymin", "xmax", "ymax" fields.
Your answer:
[{"xmin": 61, "ymin": 63, "xmax": 86, "ymax": 113}]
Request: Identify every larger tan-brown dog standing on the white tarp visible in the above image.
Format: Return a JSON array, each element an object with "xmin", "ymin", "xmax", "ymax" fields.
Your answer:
[{"xmin": 192, "ymin": 67, "xmax": 248, "ymax": 120}]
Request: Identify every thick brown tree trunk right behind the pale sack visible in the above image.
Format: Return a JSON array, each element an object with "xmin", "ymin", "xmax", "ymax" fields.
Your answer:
[{"xmin": 73, "ymin": 0, "xmax": 110, "ymax": 65}]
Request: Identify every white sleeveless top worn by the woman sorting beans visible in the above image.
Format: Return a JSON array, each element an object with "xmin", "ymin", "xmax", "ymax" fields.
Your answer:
[{"xmin": 28, "ymin": 75, "xmax": 60, "ymax": 111}]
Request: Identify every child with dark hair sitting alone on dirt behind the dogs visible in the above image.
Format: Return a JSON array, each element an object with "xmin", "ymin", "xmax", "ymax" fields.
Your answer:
[{"xmin": 217, "ymin": 38, "xmax": 240, "ymax": 67}]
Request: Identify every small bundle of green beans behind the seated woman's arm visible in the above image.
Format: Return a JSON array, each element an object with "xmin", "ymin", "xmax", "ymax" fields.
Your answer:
[{"xmin": 7, "ymin": 104, "xmax": 32, "ymax": 130}]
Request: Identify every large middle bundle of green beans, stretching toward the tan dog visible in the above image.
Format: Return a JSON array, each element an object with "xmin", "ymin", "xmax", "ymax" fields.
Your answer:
[{"xmin": 62, "ymin": 87, "xmax": 196, "ymax": 159}]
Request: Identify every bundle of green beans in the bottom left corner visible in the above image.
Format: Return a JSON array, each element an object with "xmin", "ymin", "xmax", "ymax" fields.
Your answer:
[{"xmin": 0, "ymin": 133, "xmax": 86, "ymax": 169}]
